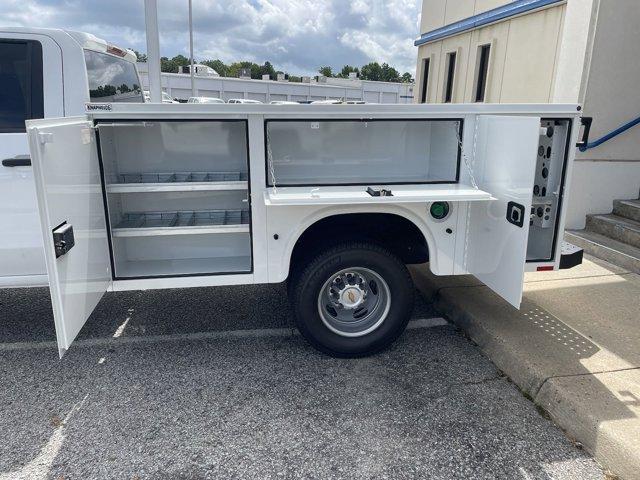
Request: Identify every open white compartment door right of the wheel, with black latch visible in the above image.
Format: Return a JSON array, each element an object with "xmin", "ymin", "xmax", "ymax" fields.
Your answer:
[{"xmin": 466, "ymin": 116, "xmax": 540, "ymax": 308}]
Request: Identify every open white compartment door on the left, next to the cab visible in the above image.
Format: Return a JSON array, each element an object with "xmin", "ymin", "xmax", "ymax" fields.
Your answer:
[{"xmin": 27, "ymin": 117, "xmax": 111, "ymax": 357}]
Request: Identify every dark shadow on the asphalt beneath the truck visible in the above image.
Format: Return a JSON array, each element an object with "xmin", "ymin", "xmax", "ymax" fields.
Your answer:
[{"xmin": 0, "ymin": 284, "xmax": 436, "ymax": 343}]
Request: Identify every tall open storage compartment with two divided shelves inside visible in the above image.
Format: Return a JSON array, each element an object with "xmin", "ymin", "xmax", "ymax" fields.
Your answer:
[{"xmin": 98, "ymin": 120, "xmax": 252, "ymax": 279}]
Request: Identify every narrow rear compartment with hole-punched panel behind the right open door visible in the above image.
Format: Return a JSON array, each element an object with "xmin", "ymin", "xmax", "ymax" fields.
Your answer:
[{"xmin": 527, "ymin": 119, "xmax": 571, "ymax": 262}]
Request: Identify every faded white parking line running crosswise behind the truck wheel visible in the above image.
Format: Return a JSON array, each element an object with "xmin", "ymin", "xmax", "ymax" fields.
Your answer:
[{"xmin": 0, "ymin": 318, "xmax": 449, "ymax": 351}]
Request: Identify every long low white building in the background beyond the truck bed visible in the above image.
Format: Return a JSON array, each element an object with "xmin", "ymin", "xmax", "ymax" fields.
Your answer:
[{"xmin": 138, "ymin": 63, "xmax": 414, "ymax": 103}]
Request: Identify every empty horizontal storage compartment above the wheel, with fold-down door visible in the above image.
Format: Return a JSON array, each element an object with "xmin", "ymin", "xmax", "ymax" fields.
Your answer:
[{"xmin": 265, "ymin": 119, "xmax": 462, "ymax": 186}]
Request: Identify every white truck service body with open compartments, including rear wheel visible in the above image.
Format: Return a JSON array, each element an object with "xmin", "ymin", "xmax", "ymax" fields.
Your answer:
[{"xmin": 27, "ymin": 103, "xmax": 587, "ymax": 357}]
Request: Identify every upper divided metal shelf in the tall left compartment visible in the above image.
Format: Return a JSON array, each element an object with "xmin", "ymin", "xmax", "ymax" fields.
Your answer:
[{"xmin": 107, "ymin": 172, "xmax": 249, "ymax": 193}]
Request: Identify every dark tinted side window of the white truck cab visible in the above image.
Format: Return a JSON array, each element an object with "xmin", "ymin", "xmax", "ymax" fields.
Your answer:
[{"xmin": 0, "ymin": 39, "xmax": 44, "ymax": 133}]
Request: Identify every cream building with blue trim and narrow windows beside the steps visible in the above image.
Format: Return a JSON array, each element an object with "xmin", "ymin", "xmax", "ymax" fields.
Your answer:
[{"xmin": 414, "ymin": 0, "xmax": 640, "ymax": 270}]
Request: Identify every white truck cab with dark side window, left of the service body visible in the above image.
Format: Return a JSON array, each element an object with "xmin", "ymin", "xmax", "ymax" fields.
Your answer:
[{"xmin": 0, "ymin": 27, "xmax": 143, "ymax": 287}]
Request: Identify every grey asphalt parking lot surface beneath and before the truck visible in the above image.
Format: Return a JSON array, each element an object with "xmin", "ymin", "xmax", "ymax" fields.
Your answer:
[{"xmin": 0, "ymin": 285, "xmax": 603, "ymax": 480}]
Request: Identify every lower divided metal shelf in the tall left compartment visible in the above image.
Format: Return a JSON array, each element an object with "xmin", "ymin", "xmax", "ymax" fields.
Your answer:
[{"xmin": 111, "ymin": 210, "xmax": 249, "ymax": 237}]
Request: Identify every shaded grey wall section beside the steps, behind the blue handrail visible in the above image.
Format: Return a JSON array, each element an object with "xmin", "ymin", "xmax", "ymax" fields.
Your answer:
[{"xmin": 568, "ymin": 0, "xmax": 640, "ymax": 228}]
